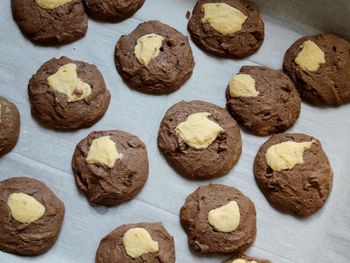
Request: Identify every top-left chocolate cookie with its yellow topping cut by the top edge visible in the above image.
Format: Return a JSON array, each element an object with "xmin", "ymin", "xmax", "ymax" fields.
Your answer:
[{"xmin": 11, "ymin": 0, "xmax": 88, "ymax": 45}]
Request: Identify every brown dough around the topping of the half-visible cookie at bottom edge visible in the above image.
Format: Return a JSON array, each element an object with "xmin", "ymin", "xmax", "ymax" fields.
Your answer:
[{"xmin": 96, "ymin": 223, "xmax": 175, "ymax": 263}]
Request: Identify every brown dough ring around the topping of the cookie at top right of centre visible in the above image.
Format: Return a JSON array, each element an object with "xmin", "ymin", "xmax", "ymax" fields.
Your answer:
[{"xmin": 188, "ymin": 0, "xmax": 264, "ymax": 58}]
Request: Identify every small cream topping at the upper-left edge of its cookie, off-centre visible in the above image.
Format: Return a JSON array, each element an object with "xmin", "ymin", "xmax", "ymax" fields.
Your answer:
[{"xmin": 229, "ymin": 74, "xmax": 260, "ymax": 98}]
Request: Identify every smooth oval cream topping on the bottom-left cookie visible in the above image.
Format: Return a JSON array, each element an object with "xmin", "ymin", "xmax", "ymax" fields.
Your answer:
[{"xmin": 7, "ymin": 193, "xmax": 45, "ymax": 224}]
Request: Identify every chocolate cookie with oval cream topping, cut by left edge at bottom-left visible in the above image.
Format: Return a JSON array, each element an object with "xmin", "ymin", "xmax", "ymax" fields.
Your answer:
[{"xmin": 0, "ymin": 177, "xmax": 64, "ymax": 256}]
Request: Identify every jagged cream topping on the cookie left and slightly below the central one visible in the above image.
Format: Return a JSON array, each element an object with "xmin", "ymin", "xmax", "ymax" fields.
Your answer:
[{"xmin": 86, "ymin": 136, "xmax": 123, "ymax": 168}]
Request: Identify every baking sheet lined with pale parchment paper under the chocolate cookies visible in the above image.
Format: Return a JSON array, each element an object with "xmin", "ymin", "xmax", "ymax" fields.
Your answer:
[{"xmin": 0, "ymin": 0, "xmax": 350, "ymax": 263}]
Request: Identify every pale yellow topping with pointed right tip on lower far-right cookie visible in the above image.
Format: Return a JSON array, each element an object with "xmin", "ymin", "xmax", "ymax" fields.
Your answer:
[{"xmin": 265, "ymin": 141, "xmax": 313, "ymax": 171}]
